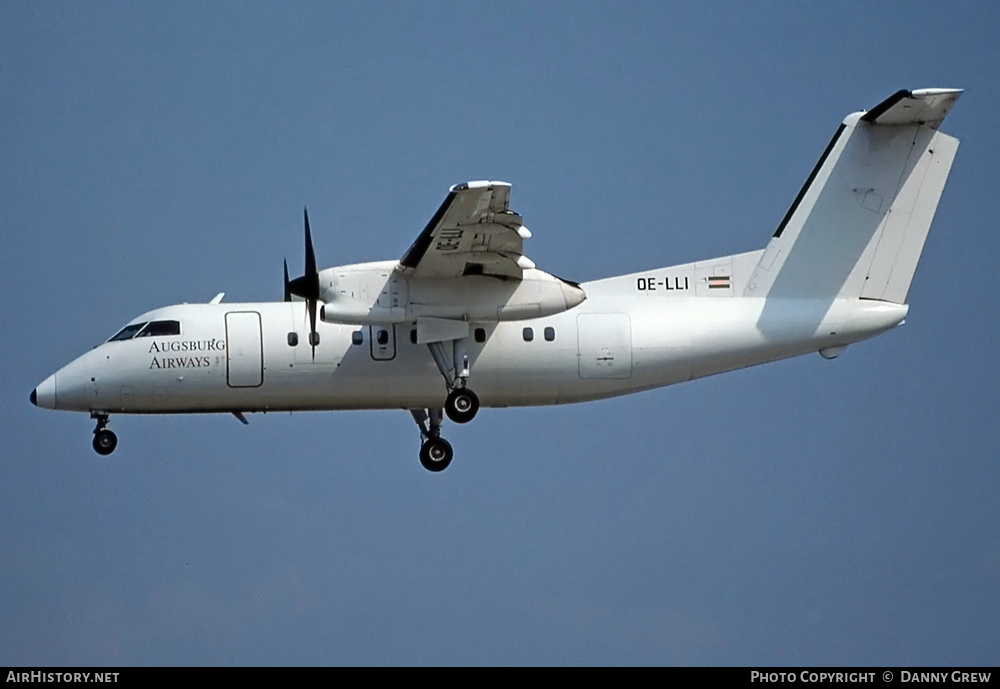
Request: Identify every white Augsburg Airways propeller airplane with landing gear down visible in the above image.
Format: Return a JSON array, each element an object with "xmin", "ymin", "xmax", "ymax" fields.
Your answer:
[{"xmin": 30, "ymin": 88, "xmax": 962, "ymax": 472}]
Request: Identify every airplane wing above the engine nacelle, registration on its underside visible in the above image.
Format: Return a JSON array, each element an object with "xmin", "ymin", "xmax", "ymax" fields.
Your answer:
[{"xmin": 398, "ymin": 182, "xmax": 535, "ymax": 280}]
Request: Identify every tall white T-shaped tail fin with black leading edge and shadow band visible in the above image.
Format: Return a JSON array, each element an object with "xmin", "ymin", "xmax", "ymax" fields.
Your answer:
[{"xmin": 744, "ymin": 89, "xmax": 962, "ymax": 304}]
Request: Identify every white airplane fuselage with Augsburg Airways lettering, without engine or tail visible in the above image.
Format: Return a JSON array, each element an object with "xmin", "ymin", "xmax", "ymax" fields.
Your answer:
[{"xmin": 36, "ymin": 271, "xmax": 908, "ymax": 414}]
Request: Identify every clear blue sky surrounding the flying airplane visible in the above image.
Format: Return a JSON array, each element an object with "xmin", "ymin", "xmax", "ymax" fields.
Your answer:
[{"xmin": 0, "ymin": 2, "xmax": 1000, "ymax": 665}]
